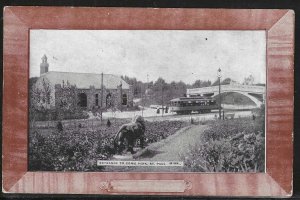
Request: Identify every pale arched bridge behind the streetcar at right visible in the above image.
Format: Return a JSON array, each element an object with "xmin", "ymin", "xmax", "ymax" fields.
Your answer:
[{"xmin": 187, "ymin": 84, "xmax": 266, "ymax": 106}]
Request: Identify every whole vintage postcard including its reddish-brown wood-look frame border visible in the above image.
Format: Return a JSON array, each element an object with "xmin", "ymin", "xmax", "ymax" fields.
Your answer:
[{"xmin": 2, "ymin": 7, "xmax": 294, "ymax": 197}]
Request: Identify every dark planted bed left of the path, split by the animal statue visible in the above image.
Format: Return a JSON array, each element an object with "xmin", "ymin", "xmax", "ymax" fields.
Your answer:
[{"xmin": 29, "ymin": 120, "xmax": 188, "ymax": 171}]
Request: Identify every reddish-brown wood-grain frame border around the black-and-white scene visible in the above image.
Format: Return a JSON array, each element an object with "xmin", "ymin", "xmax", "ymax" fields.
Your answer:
[{"xmin": 2, "ymin": 7, "xmax": 294, "ymax": 196}]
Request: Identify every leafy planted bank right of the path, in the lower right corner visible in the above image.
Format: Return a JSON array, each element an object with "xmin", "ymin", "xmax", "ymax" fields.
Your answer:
[{"xmin": 182, "ymin": 117, "xmax": 265, "ymax": 172}]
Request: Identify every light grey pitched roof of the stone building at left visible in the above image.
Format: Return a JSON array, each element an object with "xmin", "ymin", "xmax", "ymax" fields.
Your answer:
[{"xmin": 41, "ymin": 71, "xmax": 129, "ymax": 89}]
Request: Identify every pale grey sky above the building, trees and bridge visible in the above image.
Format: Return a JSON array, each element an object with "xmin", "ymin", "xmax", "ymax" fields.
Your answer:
[{"xmin": 30, "ymin": 30, "xmax": 266, "ymax": 84}]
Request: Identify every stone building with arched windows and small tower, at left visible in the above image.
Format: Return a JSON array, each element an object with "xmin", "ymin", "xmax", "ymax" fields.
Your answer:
[{"xmin": 34, "ymin": 55, "xmax": 133, "ymax": 110}]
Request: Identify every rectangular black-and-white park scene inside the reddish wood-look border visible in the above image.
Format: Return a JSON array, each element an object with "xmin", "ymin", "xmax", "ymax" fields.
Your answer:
[{"xmin": 28, "ymin": 29, "xmax": 267, "ymax": 173}]
